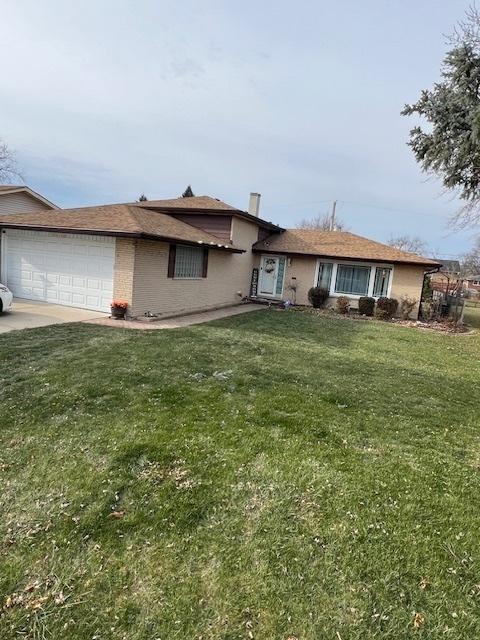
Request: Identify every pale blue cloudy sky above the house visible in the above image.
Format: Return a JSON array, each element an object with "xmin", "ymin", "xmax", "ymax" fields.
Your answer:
[{"xmin": 0, "ymin": 0, "xmax": 478, "ymax": 258}]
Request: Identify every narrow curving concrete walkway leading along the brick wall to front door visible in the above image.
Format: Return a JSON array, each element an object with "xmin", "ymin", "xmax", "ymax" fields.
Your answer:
[{"xmin": 84, "ymin": 303, "xmax": 267, "ymax": 331}]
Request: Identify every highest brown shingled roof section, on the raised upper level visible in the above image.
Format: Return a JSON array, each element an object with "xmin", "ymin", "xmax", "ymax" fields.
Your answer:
[{"xmin": 134, "ymin": 196, "xmax": 284, "ymax": 231}]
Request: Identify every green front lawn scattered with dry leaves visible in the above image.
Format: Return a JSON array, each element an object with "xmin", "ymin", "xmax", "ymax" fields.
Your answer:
[{"xmin": 0, "ymin": 311, "xmax": 480, "ymax": 640}]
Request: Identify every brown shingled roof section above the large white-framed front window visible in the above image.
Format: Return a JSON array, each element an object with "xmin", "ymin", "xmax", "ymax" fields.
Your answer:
[{"xmin": 253, "ymin": 229, "xmax": 440, "ymax": 268}]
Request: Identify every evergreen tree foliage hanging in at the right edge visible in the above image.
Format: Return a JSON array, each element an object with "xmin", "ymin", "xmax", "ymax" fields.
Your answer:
[{"xmin": 402, "ymin": 7, "xmax": 480, "ymax": 225}]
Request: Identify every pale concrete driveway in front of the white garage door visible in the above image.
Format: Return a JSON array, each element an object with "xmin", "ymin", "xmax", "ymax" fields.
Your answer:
[{"xmin": 0, "ymin": 298, "xmax": 108, "ymax": 333}]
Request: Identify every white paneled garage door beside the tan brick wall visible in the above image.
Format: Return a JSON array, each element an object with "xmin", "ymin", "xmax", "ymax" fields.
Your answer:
[{"xmin": 2, "ymin": 229, "xmax": 115, "ymax": 311}]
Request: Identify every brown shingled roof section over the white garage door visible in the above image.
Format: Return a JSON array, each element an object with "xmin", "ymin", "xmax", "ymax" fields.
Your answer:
[{"xmin": 0, "ymin": 204, "xmax": 244, "ymax": 253}]
